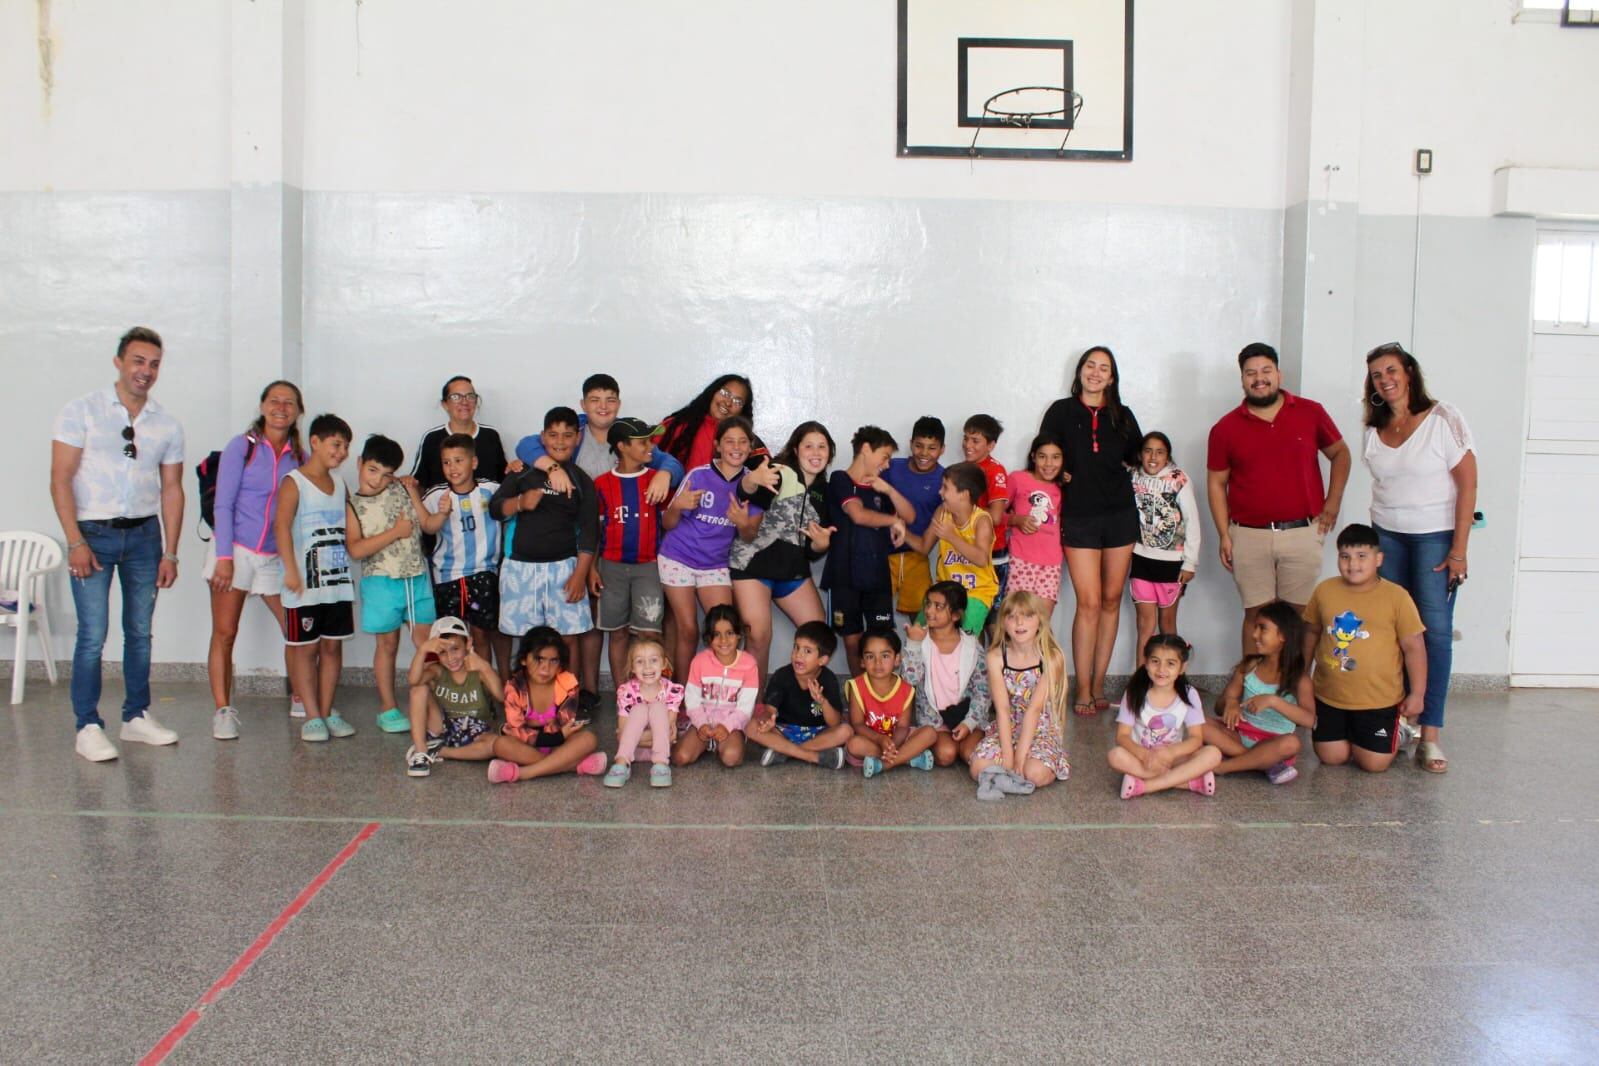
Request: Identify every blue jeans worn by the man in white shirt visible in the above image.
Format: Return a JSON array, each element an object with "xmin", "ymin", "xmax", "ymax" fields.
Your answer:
[{"xmin": 70, "ymin": 518, "xmax": 161, "ymax": 729}]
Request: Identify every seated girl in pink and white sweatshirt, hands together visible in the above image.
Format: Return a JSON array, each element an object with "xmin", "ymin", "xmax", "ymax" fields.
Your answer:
[{"xmin": 672, "ymin": 604, "xmax": 761, "ymax": 767}]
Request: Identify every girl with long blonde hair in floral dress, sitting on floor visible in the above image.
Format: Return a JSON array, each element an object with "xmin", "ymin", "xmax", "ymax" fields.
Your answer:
[{"xmin": 972, "ymin": 591, "xmax": 1071, "ymax": 799}]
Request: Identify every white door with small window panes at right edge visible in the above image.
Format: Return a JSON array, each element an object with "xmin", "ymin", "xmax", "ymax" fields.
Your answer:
[{"xmin": 1509, "ymin": 230, "xmax": 1599, "ymax": 687}]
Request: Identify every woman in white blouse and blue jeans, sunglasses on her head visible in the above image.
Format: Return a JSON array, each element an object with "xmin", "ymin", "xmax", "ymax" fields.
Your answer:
[{"xmin": 1362, "ymin": 344, "xmax": 1477, "ymax": 774}]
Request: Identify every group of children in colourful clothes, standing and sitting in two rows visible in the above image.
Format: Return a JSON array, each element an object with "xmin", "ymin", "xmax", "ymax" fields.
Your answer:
[{"xmin": 246, "ymin": 374, "xmax": 1426, "ymax": 801}]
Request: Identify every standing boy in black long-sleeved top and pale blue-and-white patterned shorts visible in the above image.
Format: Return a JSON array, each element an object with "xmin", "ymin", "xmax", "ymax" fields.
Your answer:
[{"xmin": 489, "ymin": 408, "xmax": 600, "ymax": 674}]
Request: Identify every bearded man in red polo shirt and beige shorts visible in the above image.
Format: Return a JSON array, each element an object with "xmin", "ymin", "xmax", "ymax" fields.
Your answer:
[{"xmin": 1206, "ymin": 342, "xmax": 1350, "ymax": 655}]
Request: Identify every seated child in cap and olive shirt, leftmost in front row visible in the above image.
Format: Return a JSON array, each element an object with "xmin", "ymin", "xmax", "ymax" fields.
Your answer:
[{"xmin": 405, "ymin": 615, "xmax": 505, "ymax": 777}]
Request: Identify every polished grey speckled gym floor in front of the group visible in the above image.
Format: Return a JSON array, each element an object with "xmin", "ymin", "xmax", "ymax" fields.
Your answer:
[{"xmin": 0, "ymin": 682, "xmax": 1599, "ymax": 1063}]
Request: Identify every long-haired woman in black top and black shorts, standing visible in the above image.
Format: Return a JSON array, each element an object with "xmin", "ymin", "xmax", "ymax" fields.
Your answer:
[{"xmin": 1038, "ymin": 347, "xmax": 1143, "ymax": 716}]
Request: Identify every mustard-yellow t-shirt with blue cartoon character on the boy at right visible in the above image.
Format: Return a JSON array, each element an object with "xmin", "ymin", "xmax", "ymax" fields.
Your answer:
[{"xmin": 1303, "ymin": 577, "xmax": 1426, "ymax": 711}]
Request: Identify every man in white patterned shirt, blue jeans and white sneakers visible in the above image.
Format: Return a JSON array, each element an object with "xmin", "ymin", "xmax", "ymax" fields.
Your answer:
[{"xmin": 50, "ymin": 326, "xmax": 184, "ymax": 762}]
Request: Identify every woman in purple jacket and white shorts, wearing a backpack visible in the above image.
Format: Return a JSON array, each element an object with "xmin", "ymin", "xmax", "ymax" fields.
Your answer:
[{"xmin": 201, "ymin": 382, "xmax": 305, "ymax": 740}]
